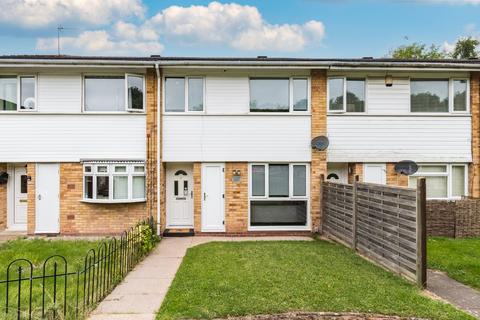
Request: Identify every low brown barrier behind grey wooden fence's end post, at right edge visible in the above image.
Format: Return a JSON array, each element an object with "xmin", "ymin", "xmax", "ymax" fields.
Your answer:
[{"xmin": 427, "ymin": 199, "xmax": 480, "ymax": 238}]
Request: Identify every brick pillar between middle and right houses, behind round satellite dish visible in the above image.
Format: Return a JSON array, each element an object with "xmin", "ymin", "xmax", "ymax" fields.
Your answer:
[{"xmin": 310, "ymin": 70, "xmax": 327, "ymax": 232}]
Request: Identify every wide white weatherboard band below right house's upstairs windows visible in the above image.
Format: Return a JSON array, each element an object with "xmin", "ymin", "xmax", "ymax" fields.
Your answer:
[{"xmin": 327, "ymin": 115, "xmax": 472, "ymax": 162}]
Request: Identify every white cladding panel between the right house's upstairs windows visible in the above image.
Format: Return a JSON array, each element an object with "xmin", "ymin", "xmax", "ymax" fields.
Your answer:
[{"xmin": 367, "ymin": 78, "xmax": 410, "ymax": 114}]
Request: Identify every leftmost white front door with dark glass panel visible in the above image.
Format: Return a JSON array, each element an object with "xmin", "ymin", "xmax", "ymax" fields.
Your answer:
[{"xmin": 12, "ymin": 165, "xmax": 28, "ymax": 228}]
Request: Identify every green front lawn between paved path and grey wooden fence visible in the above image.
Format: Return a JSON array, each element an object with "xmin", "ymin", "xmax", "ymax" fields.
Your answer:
[{"xmin": 157, "ymin": 240, "xmax": 473, "ymax": 319}]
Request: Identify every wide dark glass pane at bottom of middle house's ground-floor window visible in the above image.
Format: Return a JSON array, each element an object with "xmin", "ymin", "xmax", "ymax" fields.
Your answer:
[{"xmin": 250, "ymin": 201, "xmax": 307, "ymax": 226}]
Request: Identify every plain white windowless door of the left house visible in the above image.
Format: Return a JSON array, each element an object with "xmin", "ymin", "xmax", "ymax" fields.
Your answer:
[{"xmin": 35, "ymin": 163, "xmax": 60, "ymax": 233}]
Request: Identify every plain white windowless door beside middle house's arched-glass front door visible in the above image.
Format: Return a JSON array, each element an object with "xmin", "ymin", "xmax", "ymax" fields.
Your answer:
[{"xmin": 202, "ymin": 163, "xmax": 225, "ymax": 232}]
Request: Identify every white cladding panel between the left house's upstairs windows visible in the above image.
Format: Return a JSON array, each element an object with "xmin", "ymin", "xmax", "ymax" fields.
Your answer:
[{"xmin": 37, "ymin": 74, "xmax": 82, "ymax": 113}]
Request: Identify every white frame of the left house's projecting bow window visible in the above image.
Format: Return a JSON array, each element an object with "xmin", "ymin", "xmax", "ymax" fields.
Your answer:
[{"xmin": 81, "ymin": 162, "xmax": 147, "ymax": 204}]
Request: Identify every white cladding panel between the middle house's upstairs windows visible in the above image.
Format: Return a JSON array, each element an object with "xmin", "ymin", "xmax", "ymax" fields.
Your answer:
[{"xmin": 205, "ymin": 76, "xmax": 250, "ymax": 114}]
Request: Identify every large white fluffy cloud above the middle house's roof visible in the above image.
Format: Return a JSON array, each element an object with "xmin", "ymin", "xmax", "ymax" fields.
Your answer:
[{"xmin": 145, "ymin": 2, "xmax": 325, "ymax": 51}]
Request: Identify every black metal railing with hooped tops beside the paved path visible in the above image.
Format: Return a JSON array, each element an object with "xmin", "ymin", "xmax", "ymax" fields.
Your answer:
[{"xmin": 0, "ymin": 218, "xmax": 157, "ymax": 320}]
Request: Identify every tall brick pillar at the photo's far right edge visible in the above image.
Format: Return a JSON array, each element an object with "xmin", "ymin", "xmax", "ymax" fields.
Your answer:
[{"xmin": 468, "ymin": 72, "xmax": 480, "ymax": 198}]
